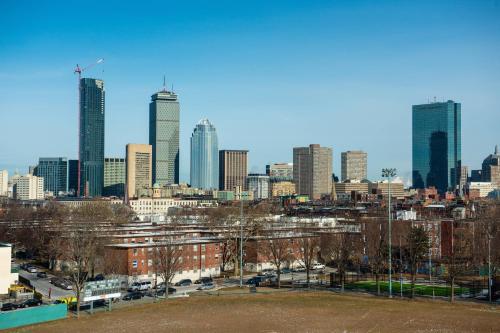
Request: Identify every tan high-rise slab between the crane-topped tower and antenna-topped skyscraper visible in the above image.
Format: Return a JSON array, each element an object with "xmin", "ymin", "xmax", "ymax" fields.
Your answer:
[{"xmin": 126, "ymin": 143, "xmax": 153, "ymax": 198}]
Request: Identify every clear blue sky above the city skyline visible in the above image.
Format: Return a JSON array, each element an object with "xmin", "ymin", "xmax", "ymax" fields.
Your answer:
[{"xmin": 0, "ymin": 0, "xmax": 500, "ymax": 181}]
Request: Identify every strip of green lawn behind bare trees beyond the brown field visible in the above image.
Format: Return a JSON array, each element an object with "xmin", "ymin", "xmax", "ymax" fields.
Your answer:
[{"xmin": 345, "ymin": 281, "xmax": 469, "ymax": 297}]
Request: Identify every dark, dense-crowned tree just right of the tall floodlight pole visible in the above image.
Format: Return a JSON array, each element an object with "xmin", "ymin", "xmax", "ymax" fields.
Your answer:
[{"xmin": 406, "ymin": 226, "xmax": 429, "ymax": 298}]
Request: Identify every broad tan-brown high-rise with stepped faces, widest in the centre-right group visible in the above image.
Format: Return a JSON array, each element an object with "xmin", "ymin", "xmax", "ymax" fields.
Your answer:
[{"xmin": 293, "ymin": 144, "xmax": 333, "ymax": 200}]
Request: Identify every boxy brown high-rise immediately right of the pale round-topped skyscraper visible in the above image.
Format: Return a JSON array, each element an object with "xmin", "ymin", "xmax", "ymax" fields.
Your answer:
[{"xmin": 219, "ymin": 150, "xmax": 248, "ymax": 191}]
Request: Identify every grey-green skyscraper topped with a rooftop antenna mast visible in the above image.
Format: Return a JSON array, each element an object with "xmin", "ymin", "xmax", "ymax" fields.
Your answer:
[{"xmin": 149, "ymin": 88, "xmax": 179, "ymax": 186}]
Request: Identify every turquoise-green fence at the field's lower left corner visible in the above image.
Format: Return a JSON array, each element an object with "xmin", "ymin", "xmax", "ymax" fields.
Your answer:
[{"xmin": 0, "ymin": 304, "xmax": 68, "ymax": 330}]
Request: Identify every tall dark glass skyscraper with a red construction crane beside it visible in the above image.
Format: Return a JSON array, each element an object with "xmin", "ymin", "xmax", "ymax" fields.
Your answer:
[{"xmin": 79, "ymin": 78, "xmax": 105, "ymax": 197}]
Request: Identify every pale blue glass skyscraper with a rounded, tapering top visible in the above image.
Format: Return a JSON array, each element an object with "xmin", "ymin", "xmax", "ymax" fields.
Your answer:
[{"xmin": 191, "ymin": 119, "xmax": 219, "ymax": 190}]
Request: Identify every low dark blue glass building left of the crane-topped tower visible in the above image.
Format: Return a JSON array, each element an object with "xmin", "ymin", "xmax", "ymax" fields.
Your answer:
[{"xmin": 35, "ymin": 157, "xmax": 68, "ymax": 196}]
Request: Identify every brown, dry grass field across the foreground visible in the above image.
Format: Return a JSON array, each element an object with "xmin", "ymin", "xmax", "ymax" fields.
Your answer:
[{"xmin": 7, "ymin": 292, "xmax": 500, "ymax": 333}]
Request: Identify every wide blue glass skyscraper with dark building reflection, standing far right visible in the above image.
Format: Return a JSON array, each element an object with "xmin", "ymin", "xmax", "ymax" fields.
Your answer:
[{"xmin": 412, "ymin": 101, "xmax": 462, "ymax": 193}]
